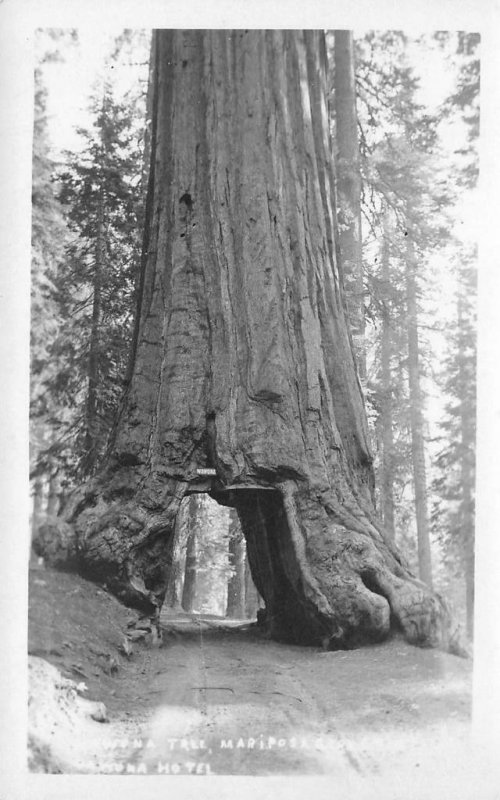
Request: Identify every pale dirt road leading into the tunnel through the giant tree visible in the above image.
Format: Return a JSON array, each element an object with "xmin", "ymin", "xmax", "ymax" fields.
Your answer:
[{"xmin": 91, "ymin": 617, "xmax": 476, "ymax": 776}]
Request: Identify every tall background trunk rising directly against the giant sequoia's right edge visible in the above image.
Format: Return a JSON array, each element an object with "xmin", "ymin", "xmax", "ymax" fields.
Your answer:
[{"xmin": 334, "ymin": 31, "xmax": 366, "ymax": 380}]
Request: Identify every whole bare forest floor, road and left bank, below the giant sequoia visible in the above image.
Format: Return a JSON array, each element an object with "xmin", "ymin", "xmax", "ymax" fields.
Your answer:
[{"xmin": 29, "ymin": 569, "xmax": 496, "ymax": 800}]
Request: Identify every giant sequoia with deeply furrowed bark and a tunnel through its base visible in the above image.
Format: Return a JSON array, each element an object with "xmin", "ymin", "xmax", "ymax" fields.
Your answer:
[{"xmin": 48, "ymin": 30, "xmax": 458, "ymax": 648}]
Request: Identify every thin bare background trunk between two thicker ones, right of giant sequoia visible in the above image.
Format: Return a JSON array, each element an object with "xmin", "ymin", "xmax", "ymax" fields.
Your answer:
[{"xmin": 380, "ymin": 212, "xmax": 396, "ymax": 541}]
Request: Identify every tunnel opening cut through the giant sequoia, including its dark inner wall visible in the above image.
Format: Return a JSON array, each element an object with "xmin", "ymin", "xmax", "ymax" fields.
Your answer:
[{"xmin": 162, "ymin": 484, "xmax": 330, "ymax": 646}]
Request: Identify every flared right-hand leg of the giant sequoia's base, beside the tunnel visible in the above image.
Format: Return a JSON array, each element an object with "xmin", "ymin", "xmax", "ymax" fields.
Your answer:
[{"xmin": 231, "ymin": 487, "xmax": 458, "ymax": 650}]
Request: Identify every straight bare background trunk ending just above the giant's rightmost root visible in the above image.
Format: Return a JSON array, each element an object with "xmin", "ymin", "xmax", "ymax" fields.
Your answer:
[{"xmin": 405, "ymin": 235, "xmax": 432, "ymax": 587}]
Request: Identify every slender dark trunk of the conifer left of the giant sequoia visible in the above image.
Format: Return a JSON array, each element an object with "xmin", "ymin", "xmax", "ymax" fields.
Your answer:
[{"xmin": 82, "ymin": 182, "xmax": 105, "ymax": 475}]
